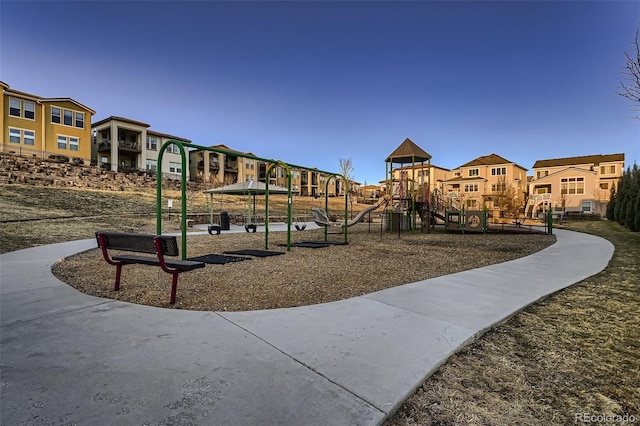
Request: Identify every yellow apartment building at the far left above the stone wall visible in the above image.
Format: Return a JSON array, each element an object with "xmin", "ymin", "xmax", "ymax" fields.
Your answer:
[{"xmin": 0, "ymin": 82, "xmax": 95, "ymax": 163}]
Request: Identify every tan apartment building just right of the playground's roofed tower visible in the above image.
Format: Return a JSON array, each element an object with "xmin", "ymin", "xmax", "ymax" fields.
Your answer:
[{"xmin": 442, "ymin": 154, "xmax": 527, "ymax": 210}]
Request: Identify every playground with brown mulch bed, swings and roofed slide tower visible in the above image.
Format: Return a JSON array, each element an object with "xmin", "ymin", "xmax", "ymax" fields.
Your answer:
[{"xmin": 45, "ymin": 139, "xmax": 555, "ymax": 311}]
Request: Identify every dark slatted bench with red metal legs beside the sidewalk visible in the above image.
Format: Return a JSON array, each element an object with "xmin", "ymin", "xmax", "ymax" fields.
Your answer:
[{"xmin": 96, "ymin": 232, "xmax": 205, "ymax": 305}]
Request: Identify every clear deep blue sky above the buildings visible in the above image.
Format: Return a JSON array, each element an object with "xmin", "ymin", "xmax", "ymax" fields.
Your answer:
[{"xmin": 0, "ymin": 0, "xmax": 640, "ymax": 183}]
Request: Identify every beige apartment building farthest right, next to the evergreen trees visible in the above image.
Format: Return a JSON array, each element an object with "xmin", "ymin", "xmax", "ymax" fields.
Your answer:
[{"xmin": 526, "ymin": 154, "xmax": 624, "ymax": 217}]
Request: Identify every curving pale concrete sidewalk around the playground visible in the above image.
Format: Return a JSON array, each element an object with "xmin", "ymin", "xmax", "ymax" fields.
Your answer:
[{"xmin": 0, "ymin": 230, "xmax": 614, "ymax": 425}]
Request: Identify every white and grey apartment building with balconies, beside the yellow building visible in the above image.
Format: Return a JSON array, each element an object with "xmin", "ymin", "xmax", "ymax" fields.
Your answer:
[{"xmin": 91, "ymin": 116, "xmax": 190, "ymax": 179}]
